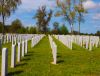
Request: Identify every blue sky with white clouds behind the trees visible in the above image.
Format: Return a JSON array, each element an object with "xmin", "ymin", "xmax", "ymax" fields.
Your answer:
[{"xmin": 6, "ymin": 0, "xmax": 100, "ymax": 33}]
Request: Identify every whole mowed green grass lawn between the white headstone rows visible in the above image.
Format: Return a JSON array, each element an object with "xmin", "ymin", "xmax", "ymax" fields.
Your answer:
[{"xmin": 0, "ymin": 36, "xmax": 100, "ymax": 76}]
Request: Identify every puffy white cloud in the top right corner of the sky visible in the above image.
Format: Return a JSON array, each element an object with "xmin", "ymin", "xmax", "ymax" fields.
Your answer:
[{"xmin": 83, "ymin": 0, "xmax": 100, "ymax": 9}]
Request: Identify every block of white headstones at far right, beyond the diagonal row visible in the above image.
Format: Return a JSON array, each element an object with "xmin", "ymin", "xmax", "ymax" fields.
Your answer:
[{"xmin": 73, "ymin": 35, "xmax": 100, "ymax": 51}]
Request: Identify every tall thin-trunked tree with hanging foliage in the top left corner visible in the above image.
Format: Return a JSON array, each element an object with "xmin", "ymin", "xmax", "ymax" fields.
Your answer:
[{"xmin": 0, "ymin": 0, "xmax": 21, "ymax": 33}]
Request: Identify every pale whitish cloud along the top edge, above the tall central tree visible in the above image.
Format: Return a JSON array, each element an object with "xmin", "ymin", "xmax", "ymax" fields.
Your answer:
[{"xmin": 19, "ymin": 0, "xmax": 56, "ymax": 12}]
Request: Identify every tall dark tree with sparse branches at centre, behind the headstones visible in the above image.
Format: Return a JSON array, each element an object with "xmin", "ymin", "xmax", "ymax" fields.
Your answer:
[{"xmin": 34, "ymin": 6, "xmax": 52, "ymax": 33}]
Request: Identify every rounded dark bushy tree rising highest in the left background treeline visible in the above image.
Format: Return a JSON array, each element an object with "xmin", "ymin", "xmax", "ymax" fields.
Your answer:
[{"xmin": 11, "ymin": 19, "xmax": 22, "ymax": 33}]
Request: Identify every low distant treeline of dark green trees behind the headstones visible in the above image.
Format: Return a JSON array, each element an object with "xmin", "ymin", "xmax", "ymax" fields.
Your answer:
[{"xmin": 0, "ymin": 19, "xmax": 100, "ymax": 36}]
